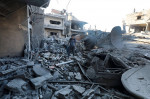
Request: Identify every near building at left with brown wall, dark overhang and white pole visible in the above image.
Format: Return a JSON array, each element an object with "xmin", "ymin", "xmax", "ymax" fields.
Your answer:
[{"xmin": 0, "ymin": 0, "xmax": 49, "ymax": 57}]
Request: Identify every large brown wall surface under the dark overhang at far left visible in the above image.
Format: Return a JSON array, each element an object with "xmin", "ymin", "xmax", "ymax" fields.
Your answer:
[{"xmin": 0, "ymin": 6, "xmax": 27, "ymax": 57}]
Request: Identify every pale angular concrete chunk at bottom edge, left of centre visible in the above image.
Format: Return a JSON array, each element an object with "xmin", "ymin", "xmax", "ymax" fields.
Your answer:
[{"xmin": 55, "ymin": 85, "xmax": 72, "ymax": 99}]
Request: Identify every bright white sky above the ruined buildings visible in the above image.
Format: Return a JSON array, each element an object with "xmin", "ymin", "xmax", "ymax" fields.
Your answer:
[{"xmin": 45, "ymin": 0, "xmax": 150, "ymax": 31}]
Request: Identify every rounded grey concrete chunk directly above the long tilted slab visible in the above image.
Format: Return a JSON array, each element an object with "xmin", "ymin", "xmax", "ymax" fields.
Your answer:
[{"xmin": 33, "ymin": 65, "xmax": 50, "ymax": 76}]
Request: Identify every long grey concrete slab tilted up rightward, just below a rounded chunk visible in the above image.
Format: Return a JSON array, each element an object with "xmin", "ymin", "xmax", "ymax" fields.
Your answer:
[{"xmin": 30, "ymin": 73, "xmax": 53, "ymax": 89}]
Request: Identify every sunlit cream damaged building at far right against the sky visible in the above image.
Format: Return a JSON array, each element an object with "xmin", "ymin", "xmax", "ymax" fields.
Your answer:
[{"xmin": 123, "ymin": 10, "xmax": 150, "ymax": 32}]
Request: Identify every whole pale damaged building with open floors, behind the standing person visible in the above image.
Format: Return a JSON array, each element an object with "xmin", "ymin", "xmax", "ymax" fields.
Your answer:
[{"xmin": 44, "ymin": 9, "xmax": 87, "ymax": 37}]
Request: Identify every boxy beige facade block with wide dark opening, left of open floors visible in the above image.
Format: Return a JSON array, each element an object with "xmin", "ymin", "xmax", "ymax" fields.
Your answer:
[{"xmin": 44, "ymin": 14, "xmax": 65, "ymax": 38}]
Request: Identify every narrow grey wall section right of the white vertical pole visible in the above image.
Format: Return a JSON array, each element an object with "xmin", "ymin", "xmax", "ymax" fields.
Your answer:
[{"xmin": 31, "ymin": 6, "xmax": 44, "ymax": 50}]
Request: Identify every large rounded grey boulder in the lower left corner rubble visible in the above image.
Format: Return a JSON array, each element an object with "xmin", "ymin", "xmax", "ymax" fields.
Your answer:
[{"xmin": 6, "ymin": 78, "xmax": 27, "ymax": 92}]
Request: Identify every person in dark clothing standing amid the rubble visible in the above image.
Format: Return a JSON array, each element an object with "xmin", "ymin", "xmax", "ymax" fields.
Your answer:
[{"xmin": 67, "ymin": 35, "xmax": 76, "ymax": 57}]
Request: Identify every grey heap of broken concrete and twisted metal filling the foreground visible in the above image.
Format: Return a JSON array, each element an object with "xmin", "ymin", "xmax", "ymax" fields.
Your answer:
[{"xmin": 0, "ymin": 38, "xmax": 145, "ymax": 99}]
